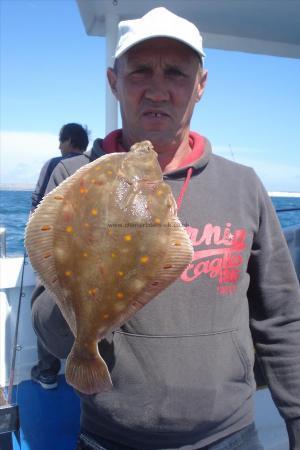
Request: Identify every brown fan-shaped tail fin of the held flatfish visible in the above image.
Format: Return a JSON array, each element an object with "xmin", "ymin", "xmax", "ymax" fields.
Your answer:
[{"xmin": 65, "ymin": 341, "xmax": 112, "ymax": 394}]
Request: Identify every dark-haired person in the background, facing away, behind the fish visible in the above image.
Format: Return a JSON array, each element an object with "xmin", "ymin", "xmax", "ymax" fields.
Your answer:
[{"xmin": 30, "ymin": 123, "xmax": 89, "ymax": 389}]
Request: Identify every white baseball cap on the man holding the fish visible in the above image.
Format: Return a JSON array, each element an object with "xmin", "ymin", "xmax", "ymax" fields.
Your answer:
[{"xmin": 115, "ymin": 7, "xmax": 205, "ymax": 59}]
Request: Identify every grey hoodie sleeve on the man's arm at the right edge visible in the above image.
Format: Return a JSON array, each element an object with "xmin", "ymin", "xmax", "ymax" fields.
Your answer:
[{"xmin": 248, "ymin": 178, "xmax": 300, "ymax": 450}]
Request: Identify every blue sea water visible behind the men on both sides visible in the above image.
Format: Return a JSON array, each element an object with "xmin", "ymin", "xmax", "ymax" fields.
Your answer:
[{"xmin": 0, "ymin": 190, "xmax": 300, "ymax": 257}]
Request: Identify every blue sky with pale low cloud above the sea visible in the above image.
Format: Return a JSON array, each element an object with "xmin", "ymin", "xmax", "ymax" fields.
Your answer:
[{"xmin": 0, "ymin": 0, "xmax": 300, "ymax": 192}]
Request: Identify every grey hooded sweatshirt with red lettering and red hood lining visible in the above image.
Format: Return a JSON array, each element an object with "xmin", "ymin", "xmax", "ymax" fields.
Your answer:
[{"xmin": 47, "ymin": 133, "xmax": 300, "ymax": 450}]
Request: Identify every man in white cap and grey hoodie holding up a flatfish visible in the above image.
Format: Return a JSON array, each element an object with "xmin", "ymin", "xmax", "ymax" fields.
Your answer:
[{"xmin": 33, "ymin": 8, "xmax": 300, "ymax": 450}]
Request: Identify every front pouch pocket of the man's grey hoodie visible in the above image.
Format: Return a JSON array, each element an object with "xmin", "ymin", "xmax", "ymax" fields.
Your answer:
[{"xmin": 102, "ymin": 330, "xmax": 251, "ymax": 433}]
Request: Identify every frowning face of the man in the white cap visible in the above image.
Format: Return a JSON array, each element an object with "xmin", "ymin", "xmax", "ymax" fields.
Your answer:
[{"xmin": 108, "ymin": 38, "xmax": 206, "ymax": 151}]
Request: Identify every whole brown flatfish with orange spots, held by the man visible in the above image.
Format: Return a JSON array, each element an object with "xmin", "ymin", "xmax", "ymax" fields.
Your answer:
[{"xmin": 25, "ymin": 141, "xmax": 193, "ymax": 394}]
